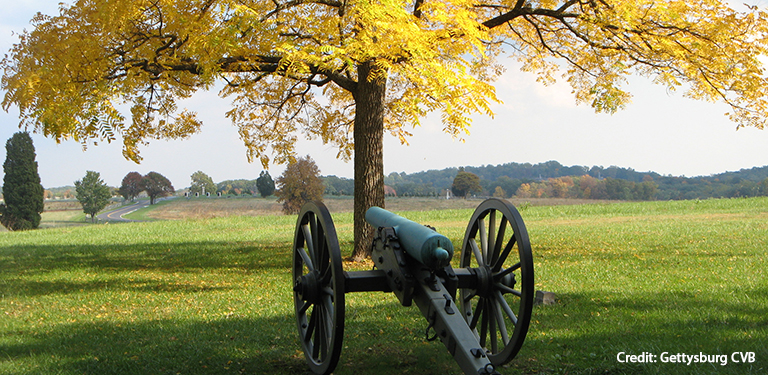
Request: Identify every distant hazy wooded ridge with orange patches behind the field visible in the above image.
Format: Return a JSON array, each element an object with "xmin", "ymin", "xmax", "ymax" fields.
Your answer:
[{"xmin": 323, "ymin": 161, "xmax": 768, "ymax": 200}]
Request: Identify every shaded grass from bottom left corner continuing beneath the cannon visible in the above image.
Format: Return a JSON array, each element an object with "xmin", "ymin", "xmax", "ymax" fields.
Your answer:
[{"xmin": 0, "ymin": 303, "xmax": 468, "ymax": 375}]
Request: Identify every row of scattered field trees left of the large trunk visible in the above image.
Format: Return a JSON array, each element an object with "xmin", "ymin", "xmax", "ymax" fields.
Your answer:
[{"xmin": 0, "ymin": 132, "xmax": 312, "ymax": 231}]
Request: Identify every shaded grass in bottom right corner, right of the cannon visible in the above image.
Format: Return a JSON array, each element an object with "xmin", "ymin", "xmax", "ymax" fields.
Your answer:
[{"xmin": 511, "ymin": 287, "xmax": 768, "ymax": 374}]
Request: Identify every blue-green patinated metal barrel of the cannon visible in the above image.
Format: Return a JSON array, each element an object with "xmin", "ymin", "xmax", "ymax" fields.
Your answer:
[{"xmin": 365, "ymin": 207, "xmax": 453, "ymax": 270}]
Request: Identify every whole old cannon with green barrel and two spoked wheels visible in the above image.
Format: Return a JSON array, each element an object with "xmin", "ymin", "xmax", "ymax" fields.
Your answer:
[{"xmin": 292, "ymin": 198, "xmax": 534, "ymax": 375}]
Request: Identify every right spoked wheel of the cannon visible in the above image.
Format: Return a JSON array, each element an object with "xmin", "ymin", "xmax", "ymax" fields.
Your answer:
[{"xmin": 459, "ymin": 199, "xmax": 534, "ymax": 366}]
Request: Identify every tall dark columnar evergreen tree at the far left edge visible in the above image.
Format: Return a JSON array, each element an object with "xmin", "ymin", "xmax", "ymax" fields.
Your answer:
[{"xmin": 0, "ymin": 132, "xmax": 45, "ymax": 230}]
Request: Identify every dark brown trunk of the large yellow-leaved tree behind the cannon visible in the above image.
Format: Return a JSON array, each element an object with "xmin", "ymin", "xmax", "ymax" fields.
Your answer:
[{"xmin": 352, "ymin": 61, "xmax": 387, "ymax": 261}]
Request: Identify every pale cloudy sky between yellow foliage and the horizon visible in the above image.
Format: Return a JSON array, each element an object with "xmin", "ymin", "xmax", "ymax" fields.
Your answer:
[{"xmin": 0, "ymin": 0, "xmax": 768, "ymax": 189}]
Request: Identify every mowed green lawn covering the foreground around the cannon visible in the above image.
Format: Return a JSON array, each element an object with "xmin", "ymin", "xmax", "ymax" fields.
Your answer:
[{"xmin": 0, "ymin": 198, "xmax": 768, "ymax": 375}]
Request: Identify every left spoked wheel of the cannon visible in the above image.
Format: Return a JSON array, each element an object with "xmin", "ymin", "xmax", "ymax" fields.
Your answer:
[{"xmin": 293, "ymin": 202, "xmax": 344, "ymax": 375}]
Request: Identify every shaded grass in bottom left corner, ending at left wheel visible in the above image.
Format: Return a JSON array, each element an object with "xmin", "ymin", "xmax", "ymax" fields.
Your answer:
[{"xmin": 0, "ymin": 316, "xmax": 306, "ymax": 375}]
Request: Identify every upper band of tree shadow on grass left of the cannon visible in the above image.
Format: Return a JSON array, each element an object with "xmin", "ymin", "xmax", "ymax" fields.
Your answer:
[{"xmin": 0, "ymin": 242, "xmax": 291, "ymax": 297}]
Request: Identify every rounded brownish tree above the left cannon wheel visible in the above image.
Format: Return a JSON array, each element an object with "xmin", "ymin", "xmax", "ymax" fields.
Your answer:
[{"xmin": 275, "ymin": 155, "xmax": 325, "ymax": 214}]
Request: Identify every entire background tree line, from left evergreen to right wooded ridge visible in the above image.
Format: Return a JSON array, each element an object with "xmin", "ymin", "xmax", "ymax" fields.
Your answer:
[{"xmin": 0, "ymin": 132, "xmax": 768, "ymax": 234}]
